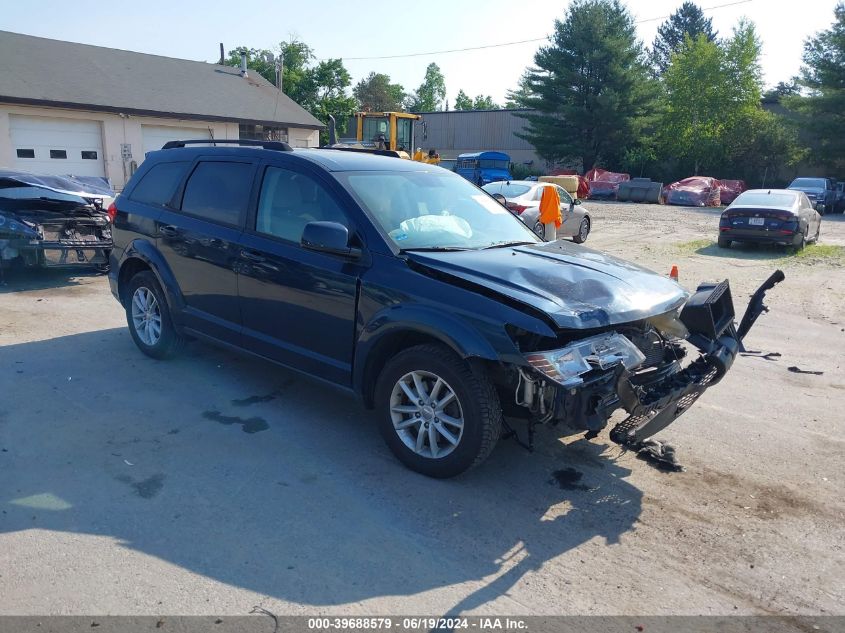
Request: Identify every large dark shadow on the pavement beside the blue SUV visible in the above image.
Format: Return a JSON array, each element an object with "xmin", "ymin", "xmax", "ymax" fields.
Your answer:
[{"xmin": 0, "ymin": 328, "xmax": 642, "ymax": 612}]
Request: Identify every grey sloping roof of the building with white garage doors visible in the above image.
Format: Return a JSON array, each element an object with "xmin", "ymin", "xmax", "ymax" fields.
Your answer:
[{"xmin": 0, "ymin": 31, "xmax": 324, "ymax": 129}]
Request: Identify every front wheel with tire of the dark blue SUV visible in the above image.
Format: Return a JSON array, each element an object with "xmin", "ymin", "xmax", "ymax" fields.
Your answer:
[{"xmin": 375, "ymin": 344, "xmax": 502, "ymax": 479}]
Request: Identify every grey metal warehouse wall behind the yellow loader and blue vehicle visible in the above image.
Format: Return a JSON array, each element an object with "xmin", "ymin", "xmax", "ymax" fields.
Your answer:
[{"xmin": 414, "ymin": 110, "xmax": 545, "ymax": 167}]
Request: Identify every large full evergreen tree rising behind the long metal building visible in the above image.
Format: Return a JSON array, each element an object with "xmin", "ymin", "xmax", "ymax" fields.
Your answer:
[{"xmin": 518, "ymin": 0, "xmax": 655, "ymax": 170}]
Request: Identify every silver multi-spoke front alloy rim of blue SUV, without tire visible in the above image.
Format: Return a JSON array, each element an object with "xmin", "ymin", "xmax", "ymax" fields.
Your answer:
[{"xmin": 390, "ymin": 370, "xmax": 464, "ymax": 459}]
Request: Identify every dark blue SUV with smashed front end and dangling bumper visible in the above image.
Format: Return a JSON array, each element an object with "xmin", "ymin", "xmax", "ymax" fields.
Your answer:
[{"xmin": 109, "ymin": 141, "xmax": 783, "ymax": 477}]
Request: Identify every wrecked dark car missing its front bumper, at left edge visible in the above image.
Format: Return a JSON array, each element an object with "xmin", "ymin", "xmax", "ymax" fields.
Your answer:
[{"xmin": 0, "ymin": 170, "xmax": 114, "ymax": 271}]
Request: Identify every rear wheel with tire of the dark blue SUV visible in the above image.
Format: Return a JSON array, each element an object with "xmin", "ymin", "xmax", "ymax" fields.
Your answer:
[{"xmin": 126, "ymin": 271, "xmax": 185, "ymax": 360}]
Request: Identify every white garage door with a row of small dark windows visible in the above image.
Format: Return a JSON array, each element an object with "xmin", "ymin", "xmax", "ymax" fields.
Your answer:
[{"xmin": 9, "ymin": 114, "xmax": 106, "ymax": 176}]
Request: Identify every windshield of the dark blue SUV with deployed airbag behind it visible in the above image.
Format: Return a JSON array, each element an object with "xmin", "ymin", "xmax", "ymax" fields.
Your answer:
[{"xmin": 337, "ymin": 170, "xmax": 541, "ymax": 250}]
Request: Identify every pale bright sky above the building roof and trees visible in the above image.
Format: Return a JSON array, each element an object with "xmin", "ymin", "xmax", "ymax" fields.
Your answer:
[{"xmin": 0, "ymin": 0, "xmax": 836, "ymax": 103}]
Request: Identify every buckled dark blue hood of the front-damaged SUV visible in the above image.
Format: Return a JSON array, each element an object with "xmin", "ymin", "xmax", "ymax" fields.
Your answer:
[{"xmin": 406, "ymin": 241, "xmax": 689, "ymax": 329}]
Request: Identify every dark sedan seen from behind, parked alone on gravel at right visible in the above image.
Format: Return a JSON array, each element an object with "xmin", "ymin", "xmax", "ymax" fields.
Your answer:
[{"xmin": 719, "ymin": 189, "xmax": 821, "ymax": 249}]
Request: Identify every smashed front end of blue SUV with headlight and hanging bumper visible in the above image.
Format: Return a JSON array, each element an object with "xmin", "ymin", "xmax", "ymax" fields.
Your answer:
[{"xmin": 500, "ymin": 271, "xmax": 784, "ymax": 460}]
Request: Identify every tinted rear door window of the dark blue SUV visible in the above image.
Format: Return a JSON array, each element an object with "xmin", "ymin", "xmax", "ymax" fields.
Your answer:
[{"xmin": 182, "ymin": 161, "xmax": 252, "ymax": 225}]
